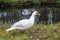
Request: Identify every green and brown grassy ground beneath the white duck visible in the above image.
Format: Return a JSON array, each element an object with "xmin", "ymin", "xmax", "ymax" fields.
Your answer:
[{"xmin": 0, "ymin": 23, "xmax": 60, "ymax": 40}]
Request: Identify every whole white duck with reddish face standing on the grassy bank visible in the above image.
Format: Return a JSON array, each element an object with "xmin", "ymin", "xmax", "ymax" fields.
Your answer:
[{"xmin": 7, "ymin": 11, "xmax": 40, "ymax": 31}]
